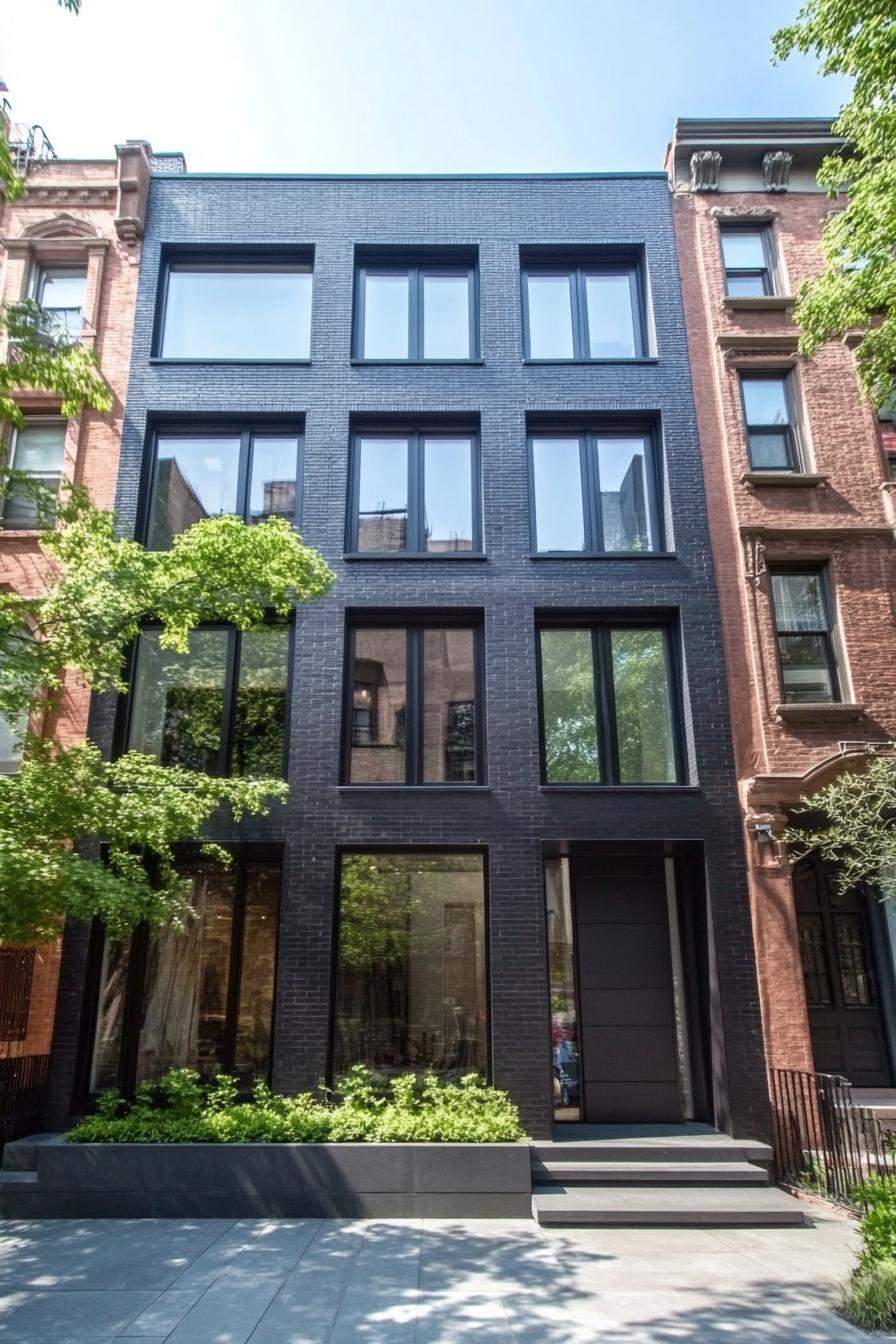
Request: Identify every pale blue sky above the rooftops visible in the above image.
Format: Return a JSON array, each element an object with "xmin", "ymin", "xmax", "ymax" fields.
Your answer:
[{"xmin": 0, "ymin": 0, "xmax": 848, "ymax": 172}]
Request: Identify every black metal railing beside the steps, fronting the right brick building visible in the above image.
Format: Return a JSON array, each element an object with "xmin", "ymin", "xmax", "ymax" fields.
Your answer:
[{"xmin": 770, "ymin": 1068, "xmax": 896, "ymax": 1210}]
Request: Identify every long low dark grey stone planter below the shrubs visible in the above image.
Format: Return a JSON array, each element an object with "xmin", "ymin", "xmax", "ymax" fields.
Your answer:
[{"xmin": 0, "ymin": 1134, "xmax": 532, "ymax": 1218}]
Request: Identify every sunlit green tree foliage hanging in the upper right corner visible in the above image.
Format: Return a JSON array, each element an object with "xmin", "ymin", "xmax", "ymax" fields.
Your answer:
[{"xmin": 772, "ymin": 0, "xmax": 896, "ymax": 407}]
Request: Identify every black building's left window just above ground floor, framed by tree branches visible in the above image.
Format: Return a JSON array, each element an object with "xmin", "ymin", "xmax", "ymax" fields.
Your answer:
[{"xmin": 126, "ymin": 625, "xmax": 290, "ymax": 777}]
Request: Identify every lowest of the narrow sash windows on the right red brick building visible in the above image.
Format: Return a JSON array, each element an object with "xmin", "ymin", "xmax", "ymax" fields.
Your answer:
[{"xmin": 771, "ymin": 570, "xmax": 840, "ymax": 704}]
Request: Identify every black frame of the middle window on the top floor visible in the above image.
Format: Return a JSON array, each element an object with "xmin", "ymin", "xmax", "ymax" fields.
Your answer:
[{"xmin": 352, "ymin": 246, "xmax": 481, "ymax": 364}]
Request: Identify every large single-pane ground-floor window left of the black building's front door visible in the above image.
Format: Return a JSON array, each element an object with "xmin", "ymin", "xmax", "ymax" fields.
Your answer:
[{"xmin": 333, "ymin": 851, "xmax": 488, "ymax": 1078}]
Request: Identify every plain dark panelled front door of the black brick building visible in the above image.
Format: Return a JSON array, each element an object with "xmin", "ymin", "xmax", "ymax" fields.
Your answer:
[{"xmin": 572, "ymin": 855, "xmax": 684, "ymax": 1124}]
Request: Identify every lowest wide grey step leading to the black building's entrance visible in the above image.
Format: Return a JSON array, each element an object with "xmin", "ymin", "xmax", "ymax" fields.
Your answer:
[{"xmin": 532, "ymin": 1185, "xmax": 805, "ymax": 1227}]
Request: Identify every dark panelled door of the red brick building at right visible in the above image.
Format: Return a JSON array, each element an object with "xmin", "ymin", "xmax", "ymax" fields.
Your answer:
[{"xmin": 794, "ymin": 857, "xmax": 893, "ymax": 1087}]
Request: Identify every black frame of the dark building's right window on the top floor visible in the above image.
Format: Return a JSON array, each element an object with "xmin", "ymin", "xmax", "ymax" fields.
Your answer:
[{"xmin": 520, "ymin": 249, "xmax": 650, "ymax": 364}]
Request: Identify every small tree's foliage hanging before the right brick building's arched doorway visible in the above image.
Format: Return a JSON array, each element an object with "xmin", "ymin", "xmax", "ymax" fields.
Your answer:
[{"xmin": 785, "ymin": 757, "xmax": 896, "ymax": 896}]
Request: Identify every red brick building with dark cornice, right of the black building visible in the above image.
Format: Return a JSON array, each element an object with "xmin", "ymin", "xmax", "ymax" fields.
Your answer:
[{"xmin": 666, "ymin": 120, "xmax": 896, "ymax": 1090}]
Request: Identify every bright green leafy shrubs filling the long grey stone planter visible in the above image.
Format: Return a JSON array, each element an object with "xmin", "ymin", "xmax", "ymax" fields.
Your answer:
[{"xmin": 66, "ymin": 1064, "xmax": 525, "ymax": 1144}]
